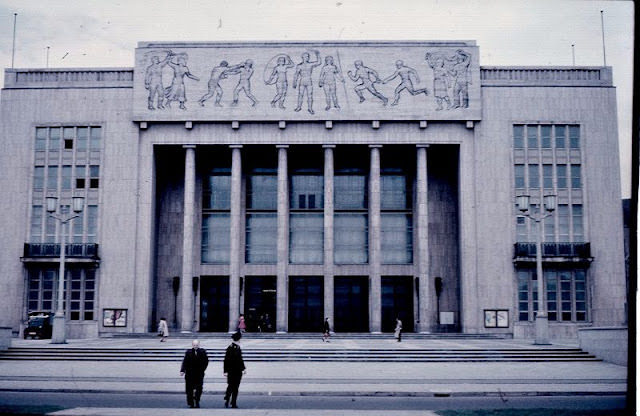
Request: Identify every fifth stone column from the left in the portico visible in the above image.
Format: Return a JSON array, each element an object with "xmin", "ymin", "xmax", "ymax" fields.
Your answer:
[{"xmin": 369, "ymin": 145, "xmax": 382, "ymax": 333}]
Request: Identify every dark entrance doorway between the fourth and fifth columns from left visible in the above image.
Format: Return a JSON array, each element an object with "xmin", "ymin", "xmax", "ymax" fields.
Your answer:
[{"xmin": 334, "ymin": 276, "xmax": 369, "ymax": 332}]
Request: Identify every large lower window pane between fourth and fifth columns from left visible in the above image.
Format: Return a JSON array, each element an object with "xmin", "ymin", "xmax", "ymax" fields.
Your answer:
[{"xmin": 334, "ymin": 214, "xmax": 369, "ymax": 264}]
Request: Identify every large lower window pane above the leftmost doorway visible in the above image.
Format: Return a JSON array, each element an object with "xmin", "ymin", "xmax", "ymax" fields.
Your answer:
[{"xmin": 201, "ymin": 213, "xmax": 231, "ymax": 264}]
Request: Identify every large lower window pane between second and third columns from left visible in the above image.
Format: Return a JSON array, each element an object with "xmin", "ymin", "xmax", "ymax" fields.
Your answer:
[{"xmin": 246, "ymin": 214, "xmax": 278, "ymax": 264}]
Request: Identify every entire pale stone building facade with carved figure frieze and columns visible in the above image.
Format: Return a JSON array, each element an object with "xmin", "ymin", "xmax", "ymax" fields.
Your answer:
[{"xmin": 0, "ymin": 41, "xmax": 626, "ymax": 337}]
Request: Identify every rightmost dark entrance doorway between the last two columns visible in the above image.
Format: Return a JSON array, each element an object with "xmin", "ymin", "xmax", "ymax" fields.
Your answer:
[{"xmin": 381, "ymin": 276, "xmax": 414, "ymax": 332}]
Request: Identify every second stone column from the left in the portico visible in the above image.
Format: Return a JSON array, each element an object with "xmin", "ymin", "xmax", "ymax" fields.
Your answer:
[{"xmin": 229, "ymin": 145, "xmax": 244, "ymax": 332}]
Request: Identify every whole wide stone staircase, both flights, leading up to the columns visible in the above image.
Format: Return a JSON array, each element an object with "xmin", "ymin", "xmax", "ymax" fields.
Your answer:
[{"xmin": 0, "ymin": 333, "xmax": 602, "ymax": 362}]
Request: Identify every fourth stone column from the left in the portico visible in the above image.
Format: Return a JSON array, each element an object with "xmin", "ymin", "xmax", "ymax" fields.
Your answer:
[{"xmin": 323, "ymin": 145, "xmax": 335, "ymax": 328}]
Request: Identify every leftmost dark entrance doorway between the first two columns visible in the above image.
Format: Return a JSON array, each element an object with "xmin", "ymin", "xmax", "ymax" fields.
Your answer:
[{"xmin": 200, "ymin": 276, "xmax": 229, "ymax": 332}]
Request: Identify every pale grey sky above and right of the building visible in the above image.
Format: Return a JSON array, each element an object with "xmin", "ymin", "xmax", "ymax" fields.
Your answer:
[{"xmin": 0, "ymin": 0, "xmax": 635, "ymax": 197}]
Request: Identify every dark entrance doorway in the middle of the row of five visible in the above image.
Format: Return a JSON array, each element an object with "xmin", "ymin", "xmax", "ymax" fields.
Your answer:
[{"xmin": 289, "ymin": 276, "xmax": 324, "ymax": 332}]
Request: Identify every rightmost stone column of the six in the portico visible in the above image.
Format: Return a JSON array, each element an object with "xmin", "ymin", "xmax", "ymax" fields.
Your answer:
[{"xmin": 415, "ymin": 145, "xmax": 432, "ymax": 332}]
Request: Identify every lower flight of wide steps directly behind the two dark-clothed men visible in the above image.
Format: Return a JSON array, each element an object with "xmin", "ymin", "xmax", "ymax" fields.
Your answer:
[{"xmin": 0, "ymin": 347, "xmax": 601, "ymax": 362}]
